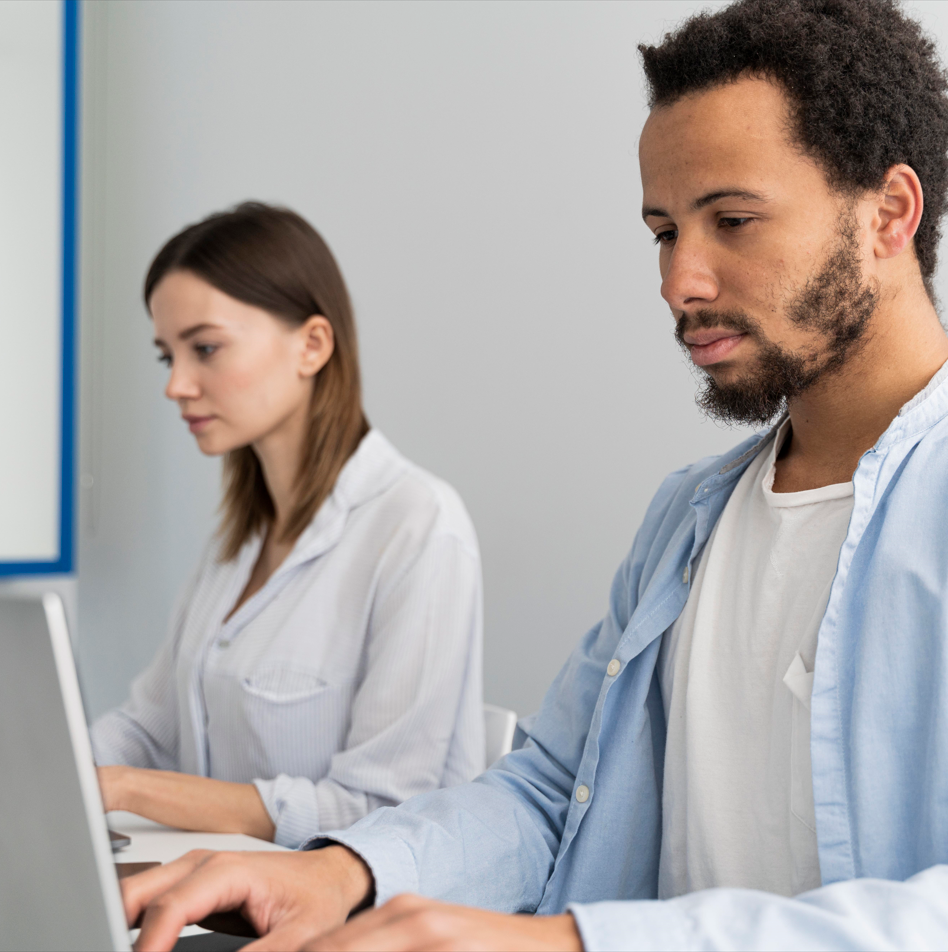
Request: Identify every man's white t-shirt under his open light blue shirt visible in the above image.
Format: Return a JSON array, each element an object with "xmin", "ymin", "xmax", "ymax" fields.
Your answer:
[{"xmin": 659, "ymin": 421, "xmax": 853, "ymax": 899}]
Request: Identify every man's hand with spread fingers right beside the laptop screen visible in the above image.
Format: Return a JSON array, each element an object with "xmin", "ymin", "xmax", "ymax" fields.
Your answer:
[{"xmin": 121, "ymin": 846, "xmax": 372, "ymax": 952}]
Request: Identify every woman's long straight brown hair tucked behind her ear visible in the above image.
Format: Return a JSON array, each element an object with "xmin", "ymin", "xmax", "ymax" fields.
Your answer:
[{"xmin": 144, "ymin": 202, "xmax": 369, "ymax": 561}]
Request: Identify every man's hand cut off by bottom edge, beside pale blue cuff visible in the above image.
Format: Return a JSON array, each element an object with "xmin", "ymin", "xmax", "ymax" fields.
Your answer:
[{"xmin": 304, "ymin": 893, "xmax": 583, "ymax": 952}]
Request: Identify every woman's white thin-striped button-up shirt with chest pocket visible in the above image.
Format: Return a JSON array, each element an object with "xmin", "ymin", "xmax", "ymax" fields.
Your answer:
[{"xmin": 92, "ymin": 430, "xmax": 484, "ymax": 846}]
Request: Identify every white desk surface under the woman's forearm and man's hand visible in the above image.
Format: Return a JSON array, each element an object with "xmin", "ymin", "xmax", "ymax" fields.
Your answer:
[{"xmin": 106, "ymin": 810, "xmax": 287, "ymax": 952}]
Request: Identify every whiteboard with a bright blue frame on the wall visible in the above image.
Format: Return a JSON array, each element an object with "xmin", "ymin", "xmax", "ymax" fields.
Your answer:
[{"xmin": 0, "ymin": 0, "xmax": 78, "ymax": 575}]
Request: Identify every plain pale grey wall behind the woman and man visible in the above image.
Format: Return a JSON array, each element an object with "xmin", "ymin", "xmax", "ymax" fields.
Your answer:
[{"xmin": 79, "ymin": 0, "xmax": 948, "ymax": 714}]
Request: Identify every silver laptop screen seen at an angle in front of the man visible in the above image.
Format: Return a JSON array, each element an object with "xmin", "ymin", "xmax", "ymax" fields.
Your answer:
[{"xmin": 0, "ymin": 594, "xmax": 130, "ymax": 952}]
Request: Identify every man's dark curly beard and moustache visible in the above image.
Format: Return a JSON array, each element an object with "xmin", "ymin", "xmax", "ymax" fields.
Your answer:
[{"xmin": 675, "ymin": 226, "xmax": 878, "ymax": 424}]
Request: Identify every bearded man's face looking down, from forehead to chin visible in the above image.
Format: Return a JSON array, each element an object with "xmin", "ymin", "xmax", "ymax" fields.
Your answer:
[{"xmin": 639, "ymin": 78, "xmax": 878, "ymax": 423}]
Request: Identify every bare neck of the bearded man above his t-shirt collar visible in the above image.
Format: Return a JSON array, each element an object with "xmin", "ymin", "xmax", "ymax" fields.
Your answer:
[{"xmin": 774, "ymin": 286, "xmax": 948, "ymax": 492}]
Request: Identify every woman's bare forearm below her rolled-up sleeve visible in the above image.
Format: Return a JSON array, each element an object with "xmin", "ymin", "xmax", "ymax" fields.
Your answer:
[{"xmin": 99, "ymin": 767, "xmax": 274, "ymax": 841}]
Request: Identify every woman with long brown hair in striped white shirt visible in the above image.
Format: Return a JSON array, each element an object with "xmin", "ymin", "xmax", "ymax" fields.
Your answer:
[{"xmin": 92, "ymin": 203, "xmax": 484, "ymax": 846}]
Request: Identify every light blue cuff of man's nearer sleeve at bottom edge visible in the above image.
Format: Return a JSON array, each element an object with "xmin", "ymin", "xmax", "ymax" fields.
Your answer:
[{"xmin": 567, "ymin": 900, "xmax": 701, "ymax": 952}]
